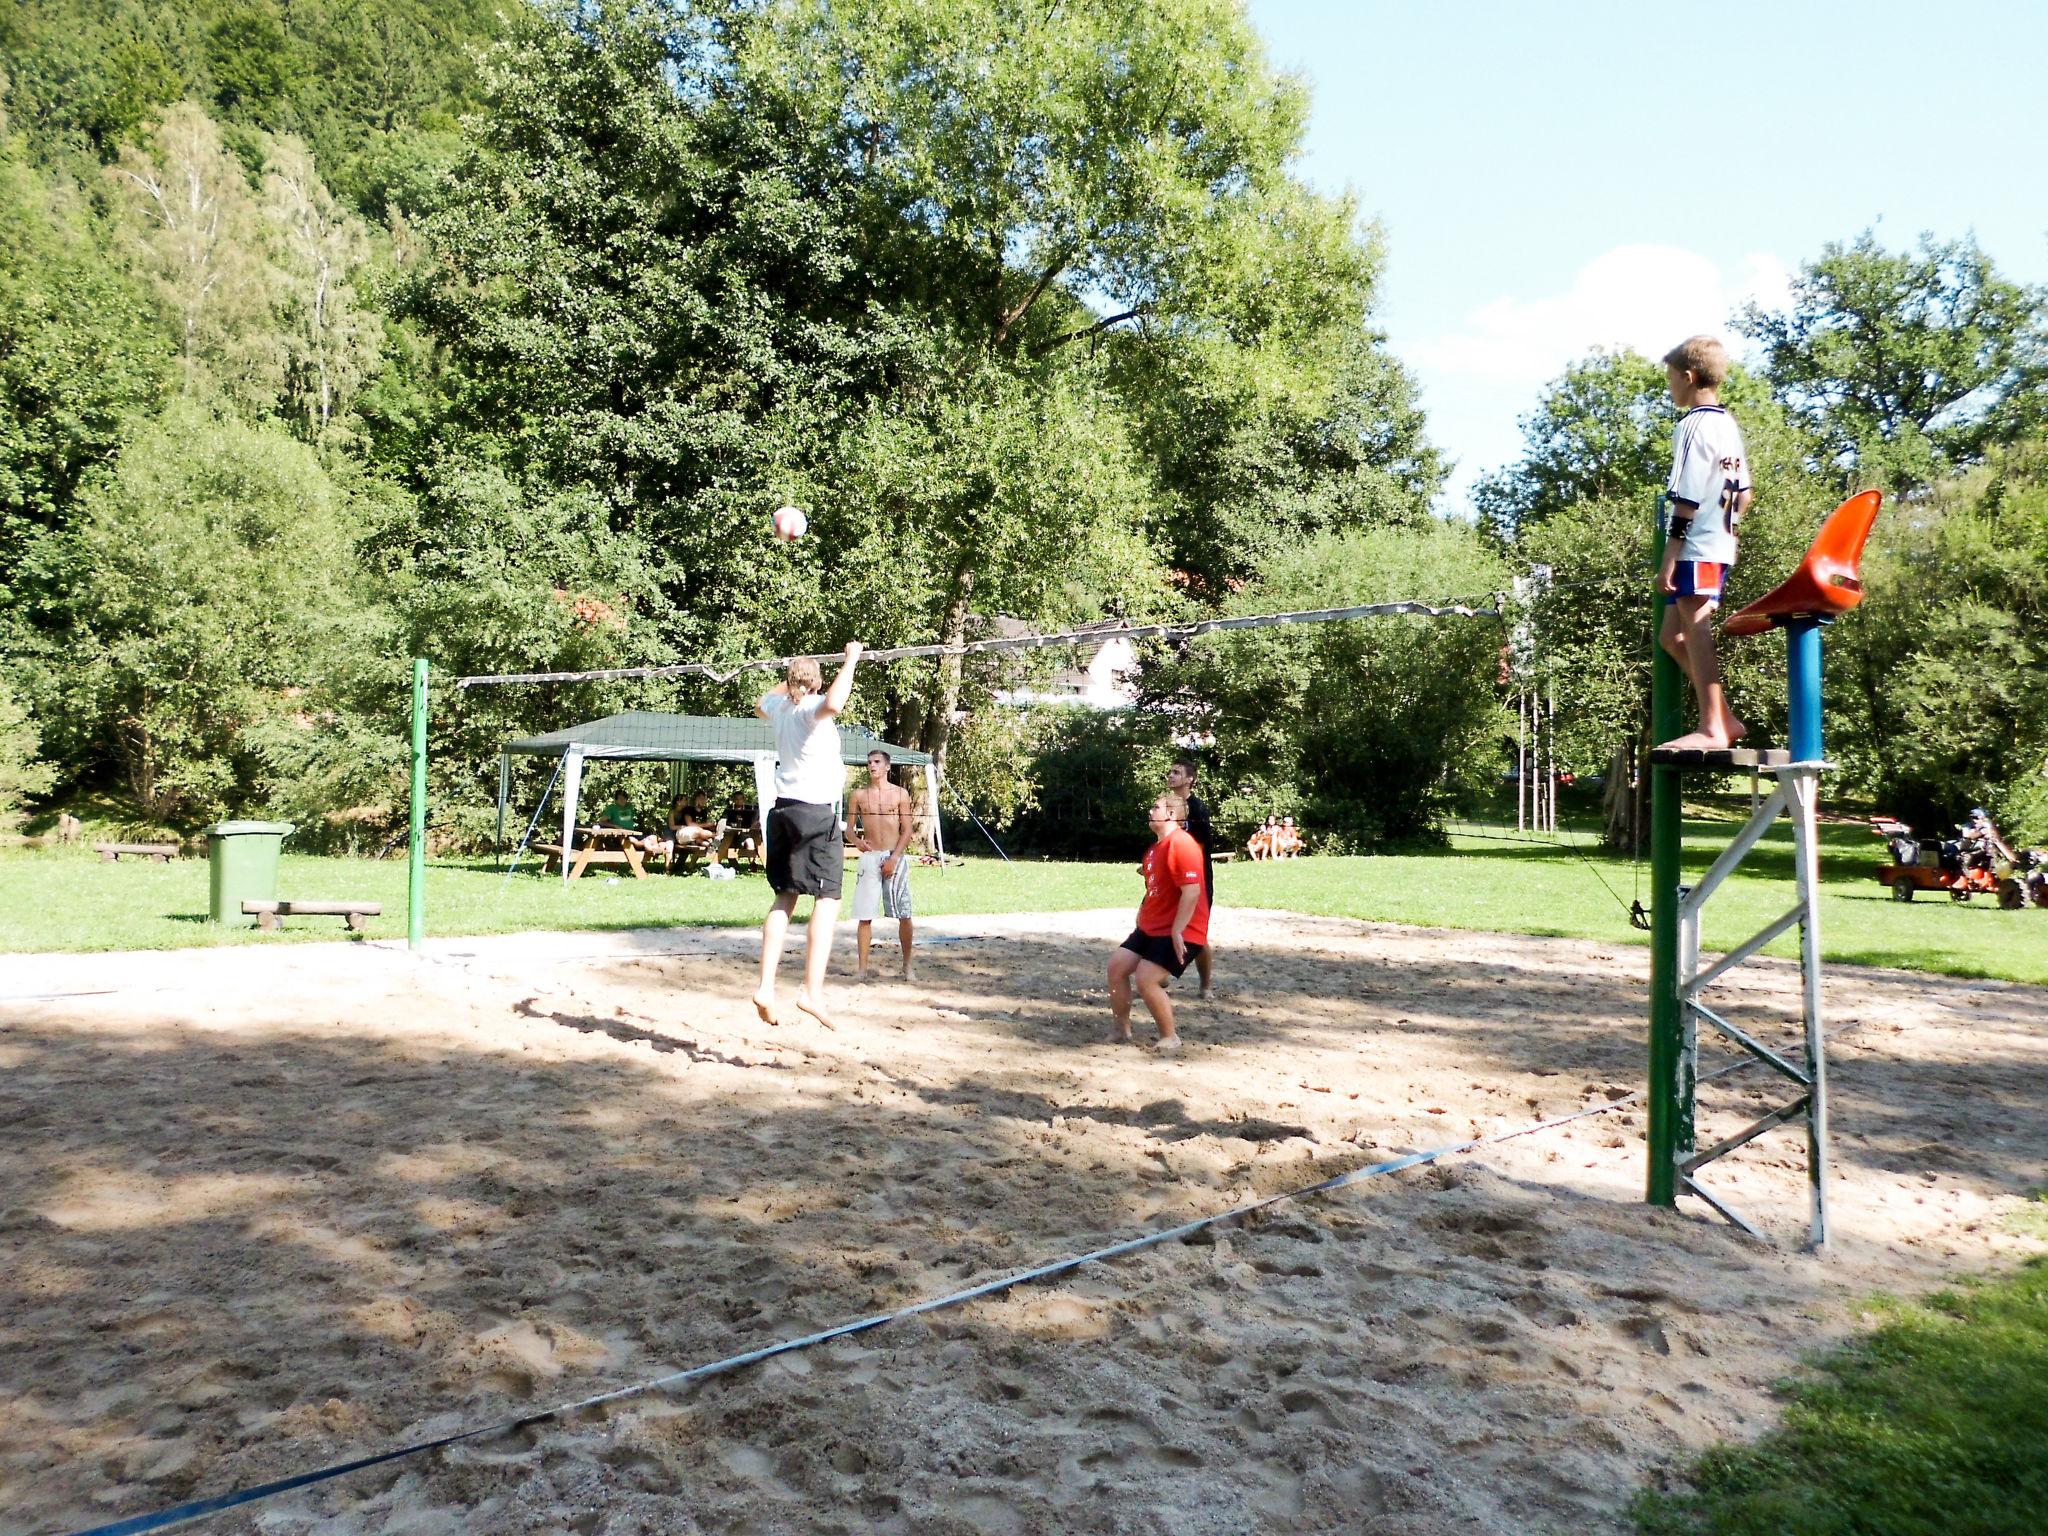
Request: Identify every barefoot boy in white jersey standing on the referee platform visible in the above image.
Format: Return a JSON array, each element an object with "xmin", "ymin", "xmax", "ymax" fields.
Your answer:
[{"xmin": 1657, "ymin": 336, "xmax": 1753, "ymax": 752}]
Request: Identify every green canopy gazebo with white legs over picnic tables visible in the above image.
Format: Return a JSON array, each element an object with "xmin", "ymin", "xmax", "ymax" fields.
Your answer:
[{"xmin": 498, "ymin": 709, "xmax": 944, "ymax": 879}]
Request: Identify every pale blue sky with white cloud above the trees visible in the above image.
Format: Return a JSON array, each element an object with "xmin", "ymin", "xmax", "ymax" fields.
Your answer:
[{"xmin": 1249, "ymin": 0, "xmax": 2048, "ymax": 510}]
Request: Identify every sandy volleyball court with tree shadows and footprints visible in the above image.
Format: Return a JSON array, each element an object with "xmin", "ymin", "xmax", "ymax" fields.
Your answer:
[{"xmin": 0, "ymin": 911, "xmax": 2048, "ymax": 1536}]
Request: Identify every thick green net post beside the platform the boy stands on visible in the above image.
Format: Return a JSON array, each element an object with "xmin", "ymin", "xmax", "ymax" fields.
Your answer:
[{"xmin": 1645, "ymin": 496, "xmax": 1683, "ymax": 1206}]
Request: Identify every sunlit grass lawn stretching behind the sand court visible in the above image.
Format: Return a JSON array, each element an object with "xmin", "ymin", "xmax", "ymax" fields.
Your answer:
[{"xmin": 0, "ymin": 815, "xmax": 2048, "ymax": 983}]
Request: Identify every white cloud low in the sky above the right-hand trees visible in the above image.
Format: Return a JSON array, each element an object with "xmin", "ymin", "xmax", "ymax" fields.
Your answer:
[{"xmin": 1395, "ymin": 246, "xmax": 1792, "ymax": 514}]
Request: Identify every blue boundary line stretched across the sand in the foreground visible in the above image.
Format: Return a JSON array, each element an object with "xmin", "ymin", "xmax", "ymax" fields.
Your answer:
[{"xmin": 51, "ymin": 1097, "xmax": 1662, "ymax": 1536}]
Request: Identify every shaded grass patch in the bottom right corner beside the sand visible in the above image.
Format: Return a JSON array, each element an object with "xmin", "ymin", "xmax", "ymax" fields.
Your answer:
[{"xmin": 1634, "ymin": 1257, "xmax": 2048, "ymax": 1536}]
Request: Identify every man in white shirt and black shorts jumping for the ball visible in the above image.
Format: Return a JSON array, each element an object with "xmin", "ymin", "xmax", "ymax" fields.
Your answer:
[{"xmin": 754, "ymin": 641, "xmax": 862, "ymax": 1030}]
